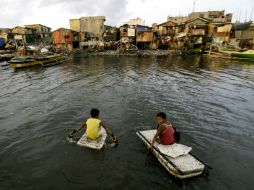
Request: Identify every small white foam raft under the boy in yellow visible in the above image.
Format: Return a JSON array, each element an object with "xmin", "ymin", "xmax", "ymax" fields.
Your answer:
[{"xmin": 77, "ymin": 127, "xmax": 107, "ymax": 150}]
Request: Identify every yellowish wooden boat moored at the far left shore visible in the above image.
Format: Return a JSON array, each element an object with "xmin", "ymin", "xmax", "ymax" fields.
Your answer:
[{"xmin": 8, "ymin": 54, "xmax": 67, "ymax": 69}]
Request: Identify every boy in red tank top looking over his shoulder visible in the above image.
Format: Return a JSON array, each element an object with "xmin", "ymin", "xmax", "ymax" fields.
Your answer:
[{"xmin": 150, "ymin": 112, "xmax": 175, "ymax": 148}]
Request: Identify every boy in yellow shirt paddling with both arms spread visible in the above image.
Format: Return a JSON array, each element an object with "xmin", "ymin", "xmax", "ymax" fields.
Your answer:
[{"xmin": 69, "ymin": 109, "xmax": 116, "ymax": 140}]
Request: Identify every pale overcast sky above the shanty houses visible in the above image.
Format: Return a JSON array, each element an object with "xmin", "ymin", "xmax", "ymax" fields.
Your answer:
[{"xmin": 0, "ymin": 0, "xmax": 254, "ymax": 29}]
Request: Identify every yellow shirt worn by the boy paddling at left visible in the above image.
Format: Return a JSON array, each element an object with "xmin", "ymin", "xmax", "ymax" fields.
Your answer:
[{"xmin": 86, "ymin": 118, "xmax": 101, "ymax": 140}]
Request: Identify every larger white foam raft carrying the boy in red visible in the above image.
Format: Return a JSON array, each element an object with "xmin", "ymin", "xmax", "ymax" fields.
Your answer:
[{"xmin": 136, "ymin": 130, "xmax": 205, "ymax": 179}]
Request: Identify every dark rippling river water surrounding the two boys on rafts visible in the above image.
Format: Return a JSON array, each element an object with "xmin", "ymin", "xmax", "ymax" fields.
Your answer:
[{"xmin": 0, "ymin": 56, "xmax": 254, "ymax": 190}]
